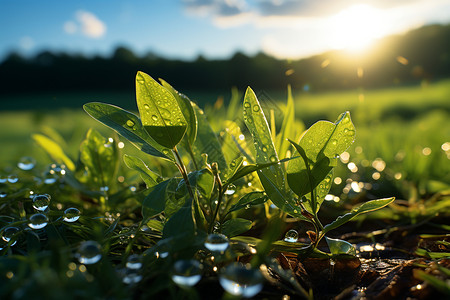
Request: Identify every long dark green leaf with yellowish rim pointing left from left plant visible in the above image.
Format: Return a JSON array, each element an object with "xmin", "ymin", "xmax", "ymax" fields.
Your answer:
[{"xmin": 83, "ymin": 102, "xmax": 175, "ymax": 161}]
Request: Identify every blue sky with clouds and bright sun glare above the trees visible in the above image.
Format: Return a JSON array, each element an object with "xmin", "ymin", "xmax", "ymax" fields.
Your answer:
[{"xmin": 0, "ymin": 0, "xmax": 450, "ymax": 60}]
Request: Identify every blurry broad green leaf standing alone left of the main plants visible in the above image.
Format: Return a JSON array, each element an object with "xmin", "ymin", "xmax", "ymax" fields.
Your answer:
[{"xmin": 80, "ymin": 129, "xmax": 119, "ymax": 187}]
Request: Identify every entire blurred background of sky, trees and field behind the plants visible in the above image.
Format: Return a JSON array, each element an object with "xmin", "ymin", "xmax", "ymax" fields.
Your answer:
[{"xmin": 0, "ymin": 0, "xmax": 450, "ymax": 198}]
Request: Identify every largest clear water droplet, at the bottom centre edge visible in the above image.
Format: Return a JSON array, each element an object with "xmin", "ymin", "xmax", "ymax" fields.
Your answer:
[{"xmin": 219, "ymin": 263, "xmax": 263, "ymax": 298}]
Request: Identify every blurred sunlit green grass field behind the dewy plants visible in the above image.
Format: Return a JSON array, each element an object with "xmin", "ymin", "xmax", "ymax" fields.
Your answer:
[{"xmin": 0, "ymin": 80, "xmax": 450, "ymax": 186}]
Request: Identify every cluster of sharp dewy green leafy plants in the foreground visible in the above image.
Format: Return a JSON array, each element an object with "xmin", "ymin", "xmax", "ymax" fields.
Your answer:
[{"xmin": 84, "ymin": 72, "xmax": 393, "ymax": 254}]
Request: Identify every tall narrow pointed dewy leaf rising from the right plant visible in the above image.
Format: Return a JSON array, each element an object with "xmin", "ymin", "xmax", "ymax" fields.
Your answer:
[{"xmin": 244, "ymin": 88, "xmax": 294, "ymax": 213}]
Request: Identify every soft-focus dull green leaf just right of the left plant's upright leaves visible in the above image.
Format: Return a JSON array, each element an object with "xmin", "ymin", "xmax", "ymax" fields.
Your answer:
[{"xmin": 192, "ymin": 103, "xmax": 227, "ymax": 174}]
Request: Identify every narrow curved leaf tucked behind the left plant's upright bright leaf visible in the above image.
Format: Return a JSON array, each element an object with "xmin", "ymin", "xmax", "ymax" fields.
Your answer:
[{"xmin": 159, "ymin": 78, "xmax": 197, "ymax": 145}]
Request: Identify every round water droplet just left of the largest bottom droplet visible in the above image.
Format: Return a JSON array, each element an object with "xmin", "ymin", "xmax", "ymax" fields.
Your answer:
[{"xmin": 172, "ymin": 259, "xmax": 203, "ymax": 287}]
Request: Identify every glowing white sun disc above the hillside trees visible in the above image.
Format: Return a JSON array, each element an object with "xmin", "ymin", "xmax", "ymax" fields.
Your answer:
[{"xmin": 329, "ymin": 4, "xmax": 388, "ymax": 51}]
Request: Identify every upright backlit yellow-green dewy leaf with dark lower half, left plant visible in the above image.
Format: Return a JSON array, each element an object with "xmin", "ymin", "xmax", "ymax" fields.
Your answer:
[{"xmin": 136, "ymin": 72, "xmax": 187, "ymax": 149}]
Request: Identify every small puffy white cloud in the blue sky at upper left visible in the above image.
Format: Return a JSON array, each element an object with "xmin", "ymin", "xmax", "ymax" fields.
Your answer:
[{"xmin": 63, "ymin": 10, "xmax": 106, "ymax": 38}]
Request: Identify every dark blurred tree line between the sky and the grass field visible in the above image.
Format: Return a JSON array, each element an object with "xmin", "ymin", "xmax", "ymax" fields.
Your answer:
[{"xmin": 0, "ymin": 25, "xmax": 450, "ymax": 94}]
